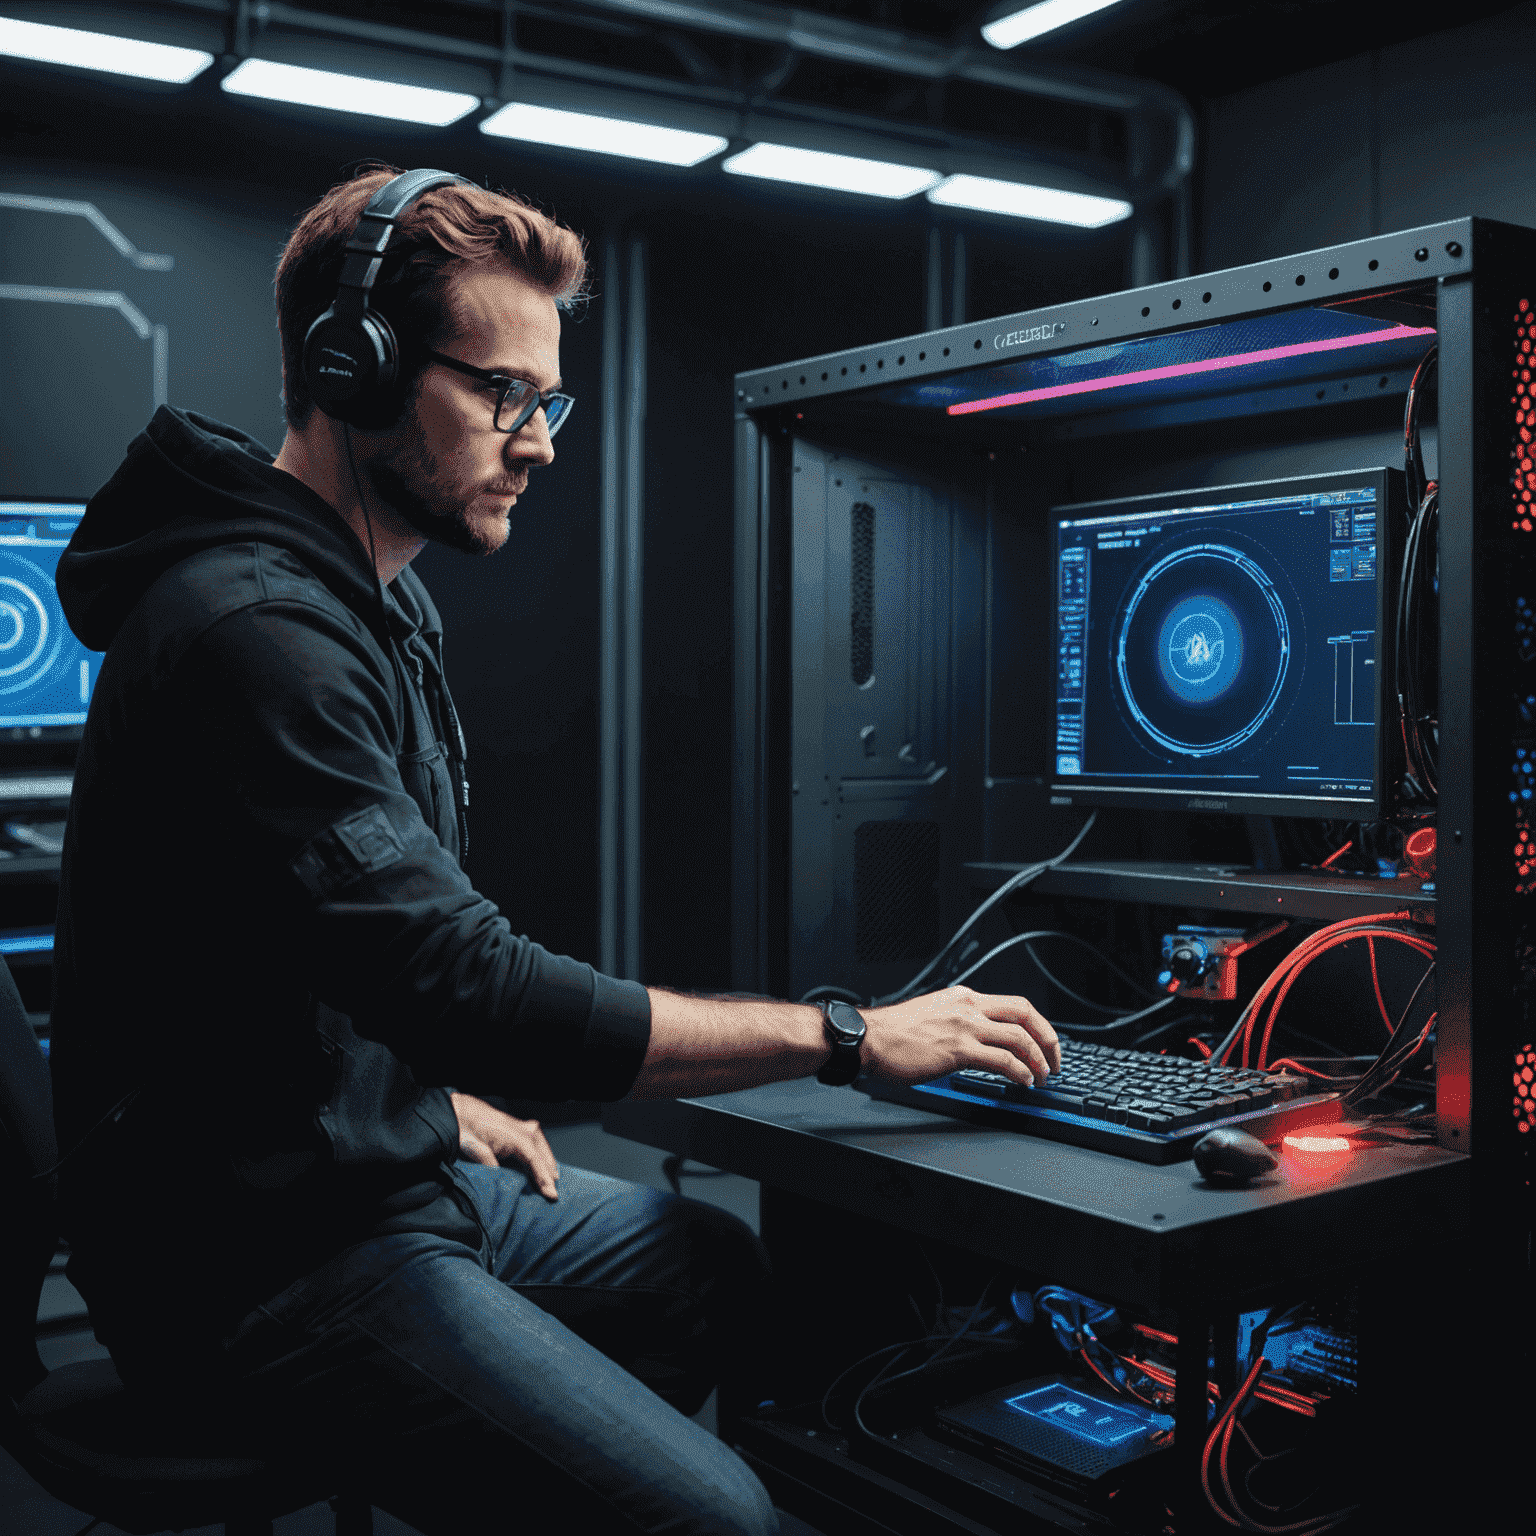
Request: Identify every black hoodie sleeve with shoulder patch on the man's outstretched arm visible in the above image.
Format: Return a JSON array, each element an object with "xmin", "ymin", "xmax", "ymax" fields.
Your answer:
[{"xmin": 172, "ymin": 589, "xmax": 650, "ymax": 1101}]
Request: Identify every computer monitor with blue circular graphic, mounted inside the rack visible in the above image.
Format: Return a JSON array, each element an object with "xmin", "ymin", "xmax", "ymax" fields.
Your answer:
[{"xmin": 1051, "ymin": 468, "xmax": 1401, "ymax": 820}]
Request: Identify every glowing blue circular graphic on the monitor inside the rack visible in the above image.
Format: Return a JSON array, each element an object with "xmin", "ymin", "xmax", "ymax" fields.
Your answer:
[{"xmin": 1114, "ymin": 544, "xmax": 1292, "ymax": 757}]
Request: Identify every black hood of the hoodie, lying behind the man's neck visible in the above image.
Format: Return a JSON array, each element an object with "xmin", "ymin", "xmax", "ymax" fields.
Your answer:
[{"xmin": 57, "ymin": 406, "xmax": 390, "ymax": 651}]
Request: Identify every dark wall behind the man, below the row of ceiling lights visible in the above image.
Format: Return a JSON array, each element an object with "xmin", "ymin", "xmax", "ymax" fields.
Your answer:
[{"xmin": 0, "ymin": 61, "xmax": 1124, "ymax": 989}]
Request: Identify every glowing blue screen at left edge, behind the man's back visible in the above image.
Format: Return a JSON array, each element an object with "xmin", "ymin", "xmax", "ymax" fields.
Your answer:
[{"xmin": 0, "ymin": 501, "xmax": 101, "ymax": 727}]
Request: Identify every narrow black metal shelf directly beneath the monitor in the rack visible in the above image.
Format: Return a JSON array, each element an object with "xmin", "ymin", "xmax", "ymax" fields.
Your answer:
[{"xmin": 965, "ymin": 860, "xmax": 1435, "ymax": 923}]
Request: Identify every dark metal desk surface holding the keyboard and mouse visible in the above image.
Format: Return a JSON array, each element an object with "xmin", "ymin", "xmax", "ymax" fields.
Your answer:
[{"xmin": 602, "ymin": 1080, "xmax": 1470, "ymax": 1309}]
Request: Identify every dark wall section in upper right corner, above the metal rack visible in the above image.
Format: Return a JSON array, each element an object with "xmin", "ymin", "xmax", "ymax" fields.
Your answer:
[{"xmin": 1201, "ymin": 5, "xmax": 1536, "ymax": 272}]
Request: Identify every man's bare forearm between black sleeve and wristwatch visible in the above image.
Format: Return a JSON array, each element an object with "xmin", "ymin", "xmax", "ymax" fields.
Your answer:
[{"xmin": 630, "ymin": 986, "xmax": 833, "ymax": 1098}]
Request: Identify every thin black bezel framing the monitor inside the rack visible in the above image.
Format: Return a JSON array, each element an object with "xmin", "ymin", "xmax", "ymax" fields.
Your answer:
[{"xmin": 1048, "ymin": 465, "xmax": 1405, "ymax": 822}]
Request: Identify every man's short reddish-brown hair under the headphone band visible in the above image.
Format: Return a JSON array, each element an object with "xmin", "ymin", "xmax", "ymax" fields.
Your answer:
[{"xmin": 276, "ymin": 164, "xmax": 587, "ymax": 427}]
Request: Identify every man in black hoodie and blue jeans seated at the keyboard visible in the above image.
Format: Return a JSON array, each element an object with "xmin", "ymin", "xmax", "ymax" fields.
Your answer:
[{"xmin": 54, "ymin": 170, "xmax": 1058, "ymax": 1533}]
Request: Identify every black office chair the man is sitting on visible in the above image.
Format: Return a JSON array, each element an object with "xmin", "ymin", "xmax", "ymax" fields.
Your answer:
[{"xmin": 0, "ymin": 965, "xmax": 373, "ymax": 1536}]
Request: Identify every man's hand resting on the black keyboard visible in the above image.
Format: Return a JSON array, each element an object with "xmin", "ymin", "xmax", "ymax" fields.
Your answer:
[{"xmin": 860, "ymin": 986, "xmax": 1061, "ymax": 1087}]
